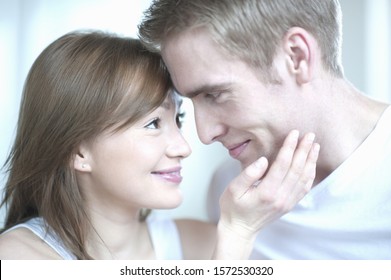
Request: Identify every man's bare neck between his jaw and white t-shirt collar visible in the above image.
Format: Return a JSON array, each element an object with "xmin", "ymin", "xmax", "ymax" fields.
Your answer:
[{"xmin": 314, "ymin": 81, "xmax": 388, "ymax": 185}]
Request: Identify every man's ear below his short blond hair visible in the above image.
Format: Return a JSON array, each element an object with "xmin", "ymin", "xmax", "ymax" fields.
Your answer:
[{"xmin": 283, "ymin": 27, "xmax": 316, "ymax": 84}]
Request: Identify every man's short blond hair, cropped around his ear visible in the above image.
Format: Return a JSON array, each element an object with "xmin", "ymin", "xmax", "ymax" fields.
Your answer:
[{"xmin": 139, "ymin": 0, "xmax": 343, "ymax": 80}]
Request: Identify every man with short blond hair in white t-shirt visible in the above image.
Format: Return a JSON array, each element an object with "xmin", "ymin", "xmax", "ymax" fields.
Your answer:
[{"xmin": 140, "ymin": 0, "xmax": 391, "ymax": 259}]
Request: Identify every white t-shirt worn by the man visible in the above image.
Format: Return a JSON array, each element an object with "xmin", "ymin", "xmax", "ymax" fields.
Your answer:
[{"xmin": 251, "ymin": 107, "xmax": 391, "ymax": 260}]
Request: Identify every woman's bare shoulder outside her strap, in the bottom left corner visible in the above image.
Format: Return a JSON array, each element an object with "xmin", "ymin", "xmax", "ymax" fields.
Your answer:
[{"xmin": 0, "ymin": 227, "xmax": 61, "ymax": 260}]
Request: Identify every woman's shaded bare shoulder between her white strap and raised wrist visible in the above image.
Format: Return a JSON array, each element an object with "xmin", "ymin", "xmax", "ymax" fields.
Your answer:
[{"xmin": 175, "ymin": 219, "xmax": 216, "ymax": 260}]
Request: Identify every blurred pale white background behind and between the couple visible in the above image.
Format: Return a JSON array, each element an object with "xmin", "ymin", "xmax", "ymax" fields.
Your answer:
[{"xmin": 0, "ymin": 0, "xmax": 391, "ymax": 225}]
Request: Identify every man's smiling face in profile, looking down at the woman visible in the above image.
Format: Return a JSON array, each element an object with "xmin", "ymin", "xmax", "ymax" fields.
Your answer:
[{"xmin": 162, "ymin": 29, "xmax": 296, "ymax": 166}]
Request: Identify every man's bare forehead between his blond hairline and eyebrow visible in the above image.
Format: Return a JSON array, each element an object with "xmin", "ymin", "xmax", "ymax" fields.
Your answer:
[{"xmin": 162, "ymin": 29, "xmax": 239, "ymax": 98}]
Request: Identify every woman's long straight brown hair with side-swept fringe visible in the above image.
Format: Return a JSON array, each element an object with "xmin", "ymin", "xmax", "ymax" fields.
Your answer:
[{"xmin": 1, "ymin": 31, "xmax": 172, "ymax": 259}]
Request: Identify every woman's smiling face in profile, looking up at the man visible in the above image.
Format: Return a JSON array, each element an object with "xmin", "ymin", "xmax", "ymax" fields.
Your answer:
[{"xmin": 82, "ymin": 94, "xmax": 191, "ymax": 214}]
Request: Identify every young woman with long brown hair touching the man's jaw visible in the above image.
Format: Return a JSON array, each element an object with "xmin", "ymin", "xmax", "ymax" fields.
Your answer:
[{"xmin": 0, "ymin": 32, "xmax": 317, "ymax": 259}]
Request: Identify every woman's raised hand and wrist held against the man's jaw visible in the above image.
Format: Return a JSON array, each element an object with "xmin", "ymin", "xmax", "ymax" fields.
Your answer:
[{"xmin": 214, "ymin": 130, "xmax": 319, "ymax": 259}]
